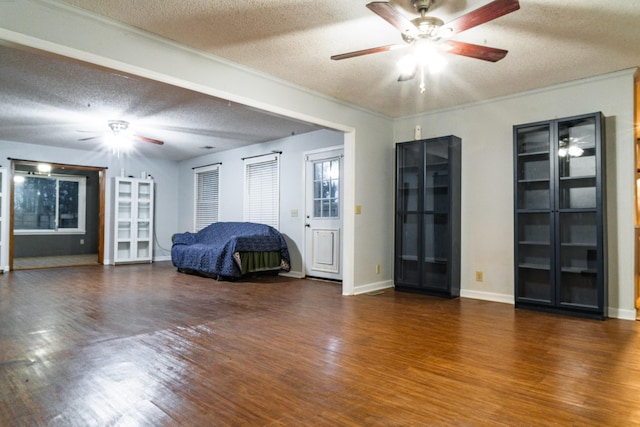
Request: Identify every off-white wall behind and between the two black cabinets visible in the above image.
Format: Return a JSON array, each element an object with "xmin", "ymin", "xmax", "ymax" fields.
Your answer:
[{"xmin": 394, "ymin": 70, "xmax": 635, "ymax": 319}]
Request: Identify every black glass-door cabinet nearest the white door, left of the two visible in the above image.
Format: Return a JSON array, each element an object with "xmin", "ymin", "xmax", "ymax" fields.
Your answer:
[{"xmin": 394, "ymin": 136, "xmax": 461, "ymax": 298}]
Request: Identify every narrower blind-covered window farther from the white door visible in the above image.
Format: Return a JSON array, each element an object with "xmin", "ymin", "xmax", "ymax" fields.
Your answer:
[{"xmin": 194, "ymin": 165, "xmax": 220, "ymax": 231}]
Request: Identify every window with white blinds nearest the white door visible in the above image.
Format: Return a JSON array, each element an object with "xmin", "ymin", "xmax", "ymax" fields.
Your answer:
[{"xmin": 244, "ymin": 154, "xmax": 280, "ymax": 228}]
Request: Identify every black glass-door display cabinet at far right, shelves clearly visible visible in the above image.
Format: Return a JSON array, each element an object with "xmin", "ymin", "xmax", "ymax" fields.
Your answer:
[{"xmin": 513, "ymin": 113, "xmax": 607, "ymax": 319}]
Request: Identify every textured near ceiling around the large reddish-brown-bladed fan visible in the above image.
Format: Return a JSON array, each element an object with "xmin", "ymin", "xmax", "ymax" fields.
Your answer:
[{"xmin": 60, "ymin": 0, "xmax": 640, "ymax": 117}]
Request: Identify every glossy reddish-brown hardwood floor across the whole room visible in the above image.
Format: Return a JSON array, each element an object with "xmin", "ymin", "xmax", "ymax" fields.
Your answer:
[{"xmin": 0, "ymin": 262, "xmax": 640, "ymax": 426}]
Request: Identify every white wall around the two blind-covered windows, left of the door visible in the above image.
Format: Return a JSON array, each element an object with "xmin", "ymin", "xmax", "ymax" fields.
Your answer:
[{"xmin": 178, "ymin": 130, "xmax": 344, "ymax": 276}]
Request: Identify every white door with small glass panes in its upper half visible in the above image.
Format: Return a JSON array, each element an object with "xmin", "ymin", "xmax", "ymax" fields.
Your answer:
[{"xmin": 304, "ymin": 148, "xmax": 344, "ymax": 280}]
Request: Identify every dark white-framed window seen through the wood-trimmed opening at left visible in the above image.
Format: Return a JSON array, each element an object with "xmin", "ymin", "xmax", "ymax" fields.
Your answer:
[{"xmin": 13, "ymin": 171, "xmax": 87, "ymax": 234}]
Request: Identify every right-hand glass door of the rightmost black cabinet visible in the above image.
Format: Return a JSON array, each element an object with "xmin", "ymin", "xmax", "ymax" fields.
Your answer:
[{"xmin": 557, "ymin": 116, "xmax": 599, "ymax": 307}]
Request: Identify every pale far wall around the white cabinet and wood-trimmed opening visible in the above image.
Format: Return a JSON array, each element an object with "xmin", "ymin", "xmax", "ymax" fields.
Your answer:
[{"xmin": 0, "ymin": 141, "xmax": 178, "ymax": 263}]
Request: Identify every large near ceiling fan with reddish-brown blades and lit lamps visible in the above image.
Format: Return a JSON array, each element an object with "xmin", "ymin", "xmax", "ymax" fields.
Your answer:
[{"xmin": 331, "ymin": 0, "xmax": 520, "ymax": 81}]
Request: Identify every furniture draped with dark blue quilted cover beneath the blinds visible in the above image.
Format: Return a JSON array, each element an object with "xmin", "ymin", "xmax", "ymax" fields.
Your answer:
[{"xmin": 171, "ymin": 222, "xmax": 291, "ymax": 279}]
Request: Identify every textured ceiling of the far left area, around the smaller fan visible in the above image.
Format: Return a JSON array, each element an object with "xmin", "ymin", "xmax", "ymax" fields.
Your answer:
[{"xmin": 0, "ymin": 45, "xmax": 319, "ymax": 160}]
